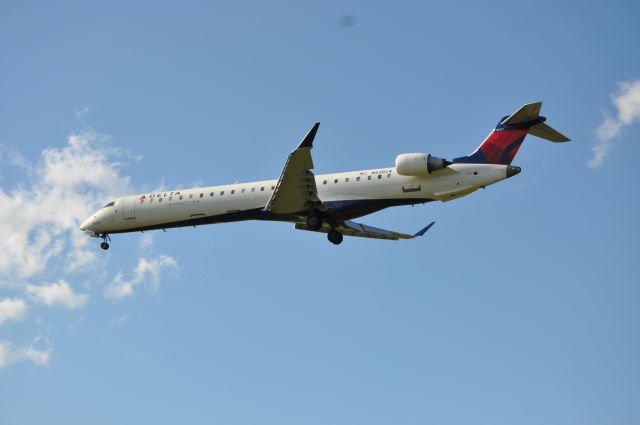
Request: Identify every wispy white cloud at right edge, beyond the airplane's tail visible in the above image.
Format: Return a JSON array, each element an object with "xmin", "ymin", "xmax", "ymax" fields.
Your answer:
[{"xmin": 587, "ymin": 80, "xmax": 640, "ymax": 168}]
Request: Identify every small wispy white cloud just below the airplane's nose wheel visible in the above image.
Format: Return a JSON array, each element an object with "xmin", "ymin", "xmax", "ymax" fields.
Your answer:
[{"xmin": 104, "ymin": 255, "xmax": 178, "ymax": 299}]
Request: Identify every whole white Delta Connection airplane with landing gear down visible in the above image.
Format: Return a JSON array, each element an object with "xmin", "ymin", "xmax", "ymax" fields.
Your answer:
[{"xmin": 80, "ymin": 102, "xmax": 569, "ymax": 250}]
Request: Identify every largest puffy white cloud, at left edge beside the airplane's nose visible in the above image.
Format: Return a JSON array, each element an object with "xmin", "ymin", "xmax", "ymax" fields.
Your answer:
[{"xmin": 0, "ymin": 131, "xmax": 129, "ymax": 283}]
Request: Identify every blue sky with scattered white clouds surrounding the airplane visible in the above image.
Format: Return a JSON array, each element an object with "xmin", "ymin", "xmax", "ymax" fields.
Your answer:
[{"xmin": 0, "ymin": 1, "xmax": 640, "ymax": 424}]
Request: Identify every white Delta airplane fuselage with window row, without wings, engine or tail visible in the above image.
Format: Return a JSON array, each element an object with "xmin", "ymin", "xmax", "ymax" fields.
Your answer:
[{"xmin": 81, "ymin": 163, "xmax": 507, "ymax": 236}]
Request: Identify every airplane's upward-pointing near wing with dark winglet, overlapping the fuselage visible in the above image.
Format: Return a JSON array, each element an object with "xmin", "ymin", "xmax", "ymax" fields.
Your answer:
[{"xmin": 265, "ymin": 123, "xmax": 326, "ymax": 214}]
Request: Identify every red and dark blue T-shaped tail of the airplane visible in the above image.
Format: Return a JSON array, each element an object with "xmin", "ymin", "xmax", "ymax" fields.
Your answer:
[{"xmin": 453, "ymin": 102, "xmax": 569, "ymax": 165}]
